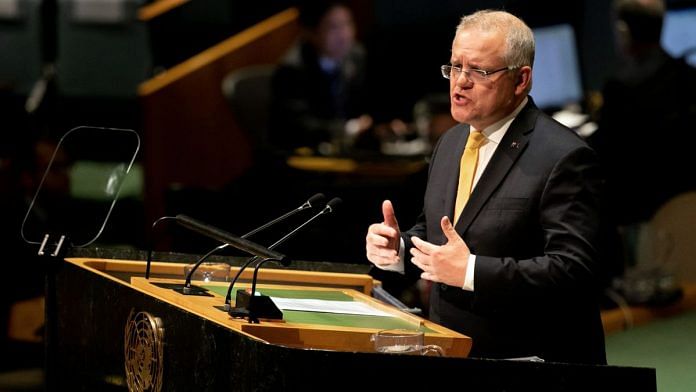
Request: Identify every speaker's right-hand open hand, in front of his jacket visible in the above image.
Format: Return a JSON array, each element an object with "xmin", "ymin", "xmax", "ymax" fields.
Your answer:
[{"xmin": 411, "ymin": 216, "xmax": 470, "ymax": 287}]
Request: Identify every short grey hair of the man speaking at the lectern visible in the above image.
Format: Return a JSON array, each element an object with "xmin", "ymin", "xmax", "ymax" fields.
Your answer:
[{"xmin": 457, "ymin": 10, "xmax": 534, "ymax": 68}]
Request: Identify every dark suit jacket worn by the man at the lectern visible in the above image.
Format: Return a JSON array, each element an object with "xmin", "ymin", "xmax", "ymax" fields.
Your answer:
[{"xmin": 404, "ymin": 98, "xmax": 606, "ymax": 363}]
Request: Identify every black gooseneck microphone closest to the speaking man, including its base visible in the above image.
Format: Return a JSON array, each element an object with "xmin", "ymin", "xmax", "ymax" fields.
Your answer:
[{"xmin": 225, "ymin": 197, "xmax": 342, "ymax": 323}]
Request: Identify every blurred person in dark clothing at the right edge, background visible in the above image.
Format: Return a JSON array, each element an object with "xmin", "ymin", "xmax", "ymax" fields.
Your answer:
[{"xmin": 590, "ymin": 0, "xmax": 696, "ymax": 225}]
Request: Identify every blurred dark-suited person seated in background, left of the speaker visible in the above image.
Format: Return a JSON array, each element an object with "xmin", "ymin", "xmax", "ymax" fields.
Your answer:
[{"xmin": 270, "ymin": 1, "xmax": 372, "ymax": 154}]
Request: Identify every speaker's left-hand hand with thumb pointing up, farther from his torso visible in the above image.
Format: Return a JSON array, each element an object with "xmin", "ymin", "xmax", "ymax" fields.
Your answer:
[{"xmin": 365, "ymin": 200, "xmax": 401, "ymax": 267}]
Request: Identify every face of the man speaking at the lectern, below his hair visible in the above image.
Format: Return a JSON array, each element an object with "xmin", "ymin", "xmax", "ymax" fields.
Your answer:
[{"xmin": 450, "ymin": 29, "xmax": 522, "ymax": 130}]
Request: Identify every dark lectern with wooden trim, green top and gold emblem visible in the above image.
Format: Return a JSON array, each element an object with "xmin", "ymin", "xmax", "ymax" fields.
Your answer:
[{"xmin": 47, "ymin": 258, "xmax": 655, "ymax": 391}]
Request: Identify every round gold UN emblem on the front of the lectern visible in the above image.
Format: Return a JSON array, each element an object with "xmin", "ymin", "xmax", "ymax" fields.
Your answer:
[{"xmin": 124, "ymin": 310, "xmax": 164, "ymax": 392}]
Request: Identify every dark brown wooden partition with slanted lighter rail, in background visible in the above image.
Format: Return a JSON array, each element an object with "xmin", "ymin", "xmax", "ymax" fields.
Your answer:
[{"xmin": 139, "ymin": 8, "xmax": 299, "ymax": 222}]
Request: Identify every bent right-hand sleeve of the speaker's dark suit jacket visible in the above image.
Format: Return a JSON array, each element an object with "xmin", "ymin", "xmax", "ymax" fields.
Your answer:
[{"xmin": 474, "ymin": 147, "xmax": 601, "ymax": 309}]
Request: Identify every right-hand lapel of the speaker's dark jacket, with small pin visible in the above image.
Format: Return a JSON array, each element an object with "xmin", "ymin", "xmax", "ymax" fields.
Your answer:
[{"xmin": 454, "ymin": 102, "xmax": 539, "ymax": 234}]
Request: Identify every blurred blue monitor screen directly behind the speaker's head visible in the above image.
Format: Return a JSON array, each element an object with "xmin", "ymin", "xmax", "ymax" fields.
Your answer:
[{"xmin": 531, "ymin": 24, "xmax": 583, "ymax": 109}]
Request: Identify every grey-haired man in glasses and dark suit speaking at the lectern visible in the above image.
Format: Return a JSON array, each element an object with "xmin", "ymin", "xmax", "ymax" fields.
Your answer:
[{"xmin": 366, "ymin": 11, "xmax": 606, "ymax": 363}]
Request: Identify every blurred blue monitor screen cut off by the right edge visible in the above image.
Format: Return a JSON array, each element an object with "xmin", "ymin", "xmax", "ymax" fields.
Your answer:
[{"xmin": 662, "ymin": 7, "xmax": 696, "ymax": 67}]
